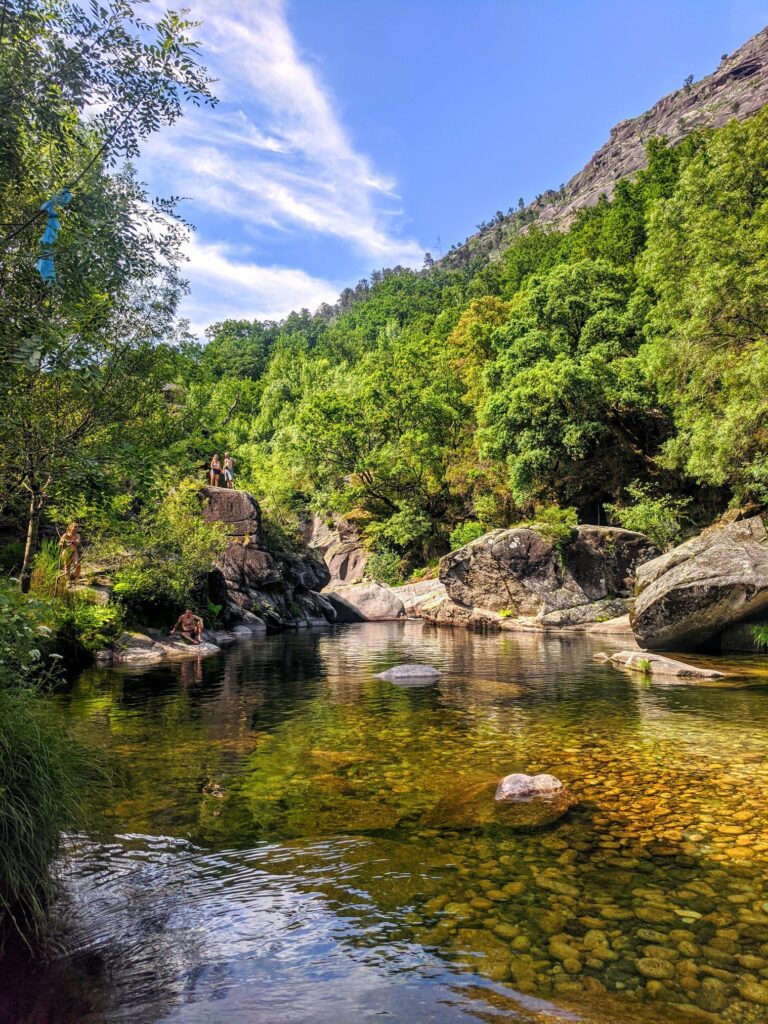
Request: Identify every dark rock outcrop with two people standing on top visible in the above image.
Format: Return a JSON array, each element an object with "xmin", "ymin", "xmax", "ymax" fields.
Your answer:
[{"xmin": 201, "ymin": 487, "xmax": 336, "ymax": 629}]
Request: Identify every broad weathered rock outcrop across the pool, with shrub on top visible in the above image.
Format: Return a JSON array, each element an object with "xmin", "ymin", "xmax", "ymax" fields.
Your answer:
[{"xmin": 422, "ymin": 526, "xmax": 656, "ymax": 629}]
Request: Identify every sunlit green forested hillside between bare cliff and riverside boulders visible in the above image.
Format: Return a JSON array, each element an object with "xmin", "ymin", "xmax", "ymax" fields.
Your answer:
[{"xmin": 179, "ymin": 111, "xmax": 768, "ymax": 575}]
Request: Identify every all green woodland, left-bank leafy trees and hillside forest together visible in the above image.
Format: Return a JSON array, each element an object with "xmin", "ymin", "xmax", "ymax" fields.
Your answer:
[{"xmin": 0, "ymin": 0, "xmax": 768, "ymax": 942}]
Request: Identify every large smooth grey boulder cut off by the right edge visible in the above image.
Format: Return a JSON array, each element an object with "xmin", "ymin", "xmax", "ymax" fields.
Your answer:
[{"xmin": 632, "ymin": 516, "xmax": 768, "ymax": 650}]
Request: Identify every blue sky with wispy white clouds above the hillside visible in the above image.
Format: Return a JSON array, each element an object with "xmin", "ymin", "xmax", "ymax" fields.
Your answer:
[{"xmin": 139, "ymin": 0, "xmax": 768, "ymax": 333}]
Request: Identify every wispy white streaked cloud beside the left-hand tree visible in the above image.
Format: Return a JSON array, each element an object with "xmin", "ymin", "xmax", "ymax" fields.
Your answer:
[{"xmin": 145, "ymin": 0, "xmax": 423, "ymax": 319}]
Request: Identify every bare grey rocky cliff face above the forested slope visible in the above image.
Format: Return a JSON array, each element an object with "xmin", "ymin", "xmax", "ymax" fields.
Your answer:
[{"xmin": 449, "ymin": 28, "xmax": 768, "ymax": 261}]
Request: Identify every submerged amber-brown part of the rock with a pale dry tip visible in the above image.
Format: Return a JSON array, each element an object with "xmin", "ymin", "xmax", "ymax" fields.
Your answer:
[{"xmin": 422, "ymin": 775, "xmax": 577, "ymax": 829}]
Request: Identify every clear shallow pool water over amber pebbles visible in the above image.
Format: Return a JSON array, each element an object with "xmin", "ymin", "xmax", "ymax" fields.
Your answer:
[{"xmin": 12, "ymin": 623, "xmax": 768, "ymax": 1024}]
